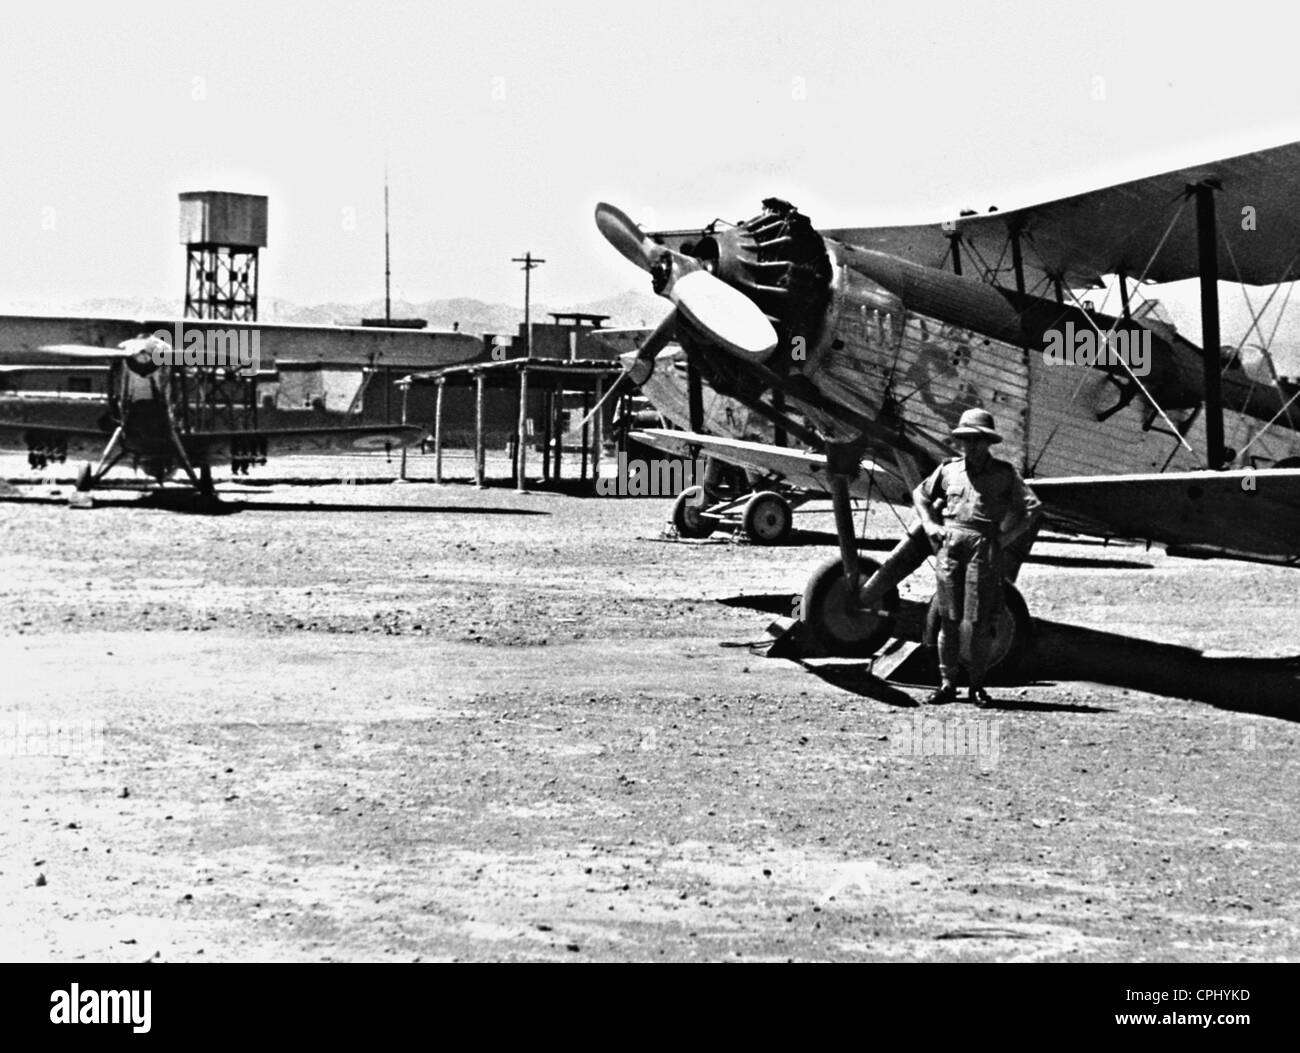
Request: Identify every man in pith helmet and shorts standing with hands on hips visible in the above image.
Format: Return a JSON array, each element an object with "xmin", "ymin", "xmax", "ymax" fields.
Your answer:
[{"xmin": 913, "ymin": 410, "xmax": 1041, "ymax": 707}]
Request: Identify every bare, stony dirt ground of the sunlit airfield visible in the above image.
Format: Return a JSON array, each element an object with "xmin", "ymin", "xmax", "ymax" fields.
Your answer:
[{"xmin": 0, "ymin": 447, "xmax": 1300, "ymax": 962}]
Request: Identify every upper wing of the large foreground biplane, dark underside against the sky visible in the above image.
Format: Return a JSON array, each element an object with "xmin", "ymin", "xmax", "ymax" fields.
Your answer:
[{"xmin": 822, "ymin": 143, "xmax": 1300, "ymax": 287}]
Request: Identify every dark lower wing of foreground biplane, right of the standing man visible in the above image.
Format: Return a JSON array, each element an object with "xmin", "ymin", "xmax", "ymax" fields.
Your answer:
[{"xmin": 1030, "ymin": 468, "xmax": 1300, "ymax": 563}]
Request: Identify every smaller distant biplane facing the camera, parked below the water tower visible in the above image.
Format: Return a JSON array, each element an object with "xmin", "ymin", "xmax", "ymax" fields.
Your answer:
[{"xmin": 0, "ymin": 321, "xmax": 424, "ymax": 506}]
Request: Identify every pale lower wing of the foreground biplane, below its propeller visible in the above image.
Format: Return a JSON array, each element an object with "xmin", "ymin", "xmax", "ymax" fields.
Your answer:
[{"xmin": 631, "ymin": 428, "xmax": 910, "ymax": 502}]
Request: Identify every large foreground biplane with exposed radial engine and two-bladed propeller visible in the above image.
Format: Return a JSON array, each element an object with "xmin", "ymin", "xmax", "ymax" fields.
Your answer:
[{"xmin": 595, "ymin": 143, "xmax": 1300, "ymax": 663}]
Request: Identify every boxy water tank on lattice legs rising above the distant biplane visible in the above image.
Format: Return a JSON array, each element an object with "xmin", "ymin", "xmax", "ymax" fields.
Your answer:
[{"xmin": 181, "ymin": 190, "xmax": 267, "ymax": 321}]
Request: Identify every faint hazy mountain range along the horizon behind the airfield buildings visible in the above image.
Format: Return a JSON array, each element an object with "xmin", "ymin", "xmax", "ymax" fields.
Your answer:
[{"xmin": 0, "ymin": 290, "xmax": 671, "ymax": 337}]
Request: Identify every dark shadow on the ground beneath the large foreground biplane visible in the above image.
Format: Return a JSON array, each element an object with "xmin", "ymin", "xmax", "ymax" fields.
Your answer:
[{"xmin": 719, "ymin": 593, "xmax": 1300, "ymax": 722}]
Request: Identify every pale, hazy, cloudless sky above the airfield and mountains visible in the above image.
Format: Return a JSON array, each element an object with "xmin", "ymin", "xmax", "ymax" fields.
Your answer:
[{"xmin": 0, "ymin": 0, "xmax": 1300, "ymax": 319}]
